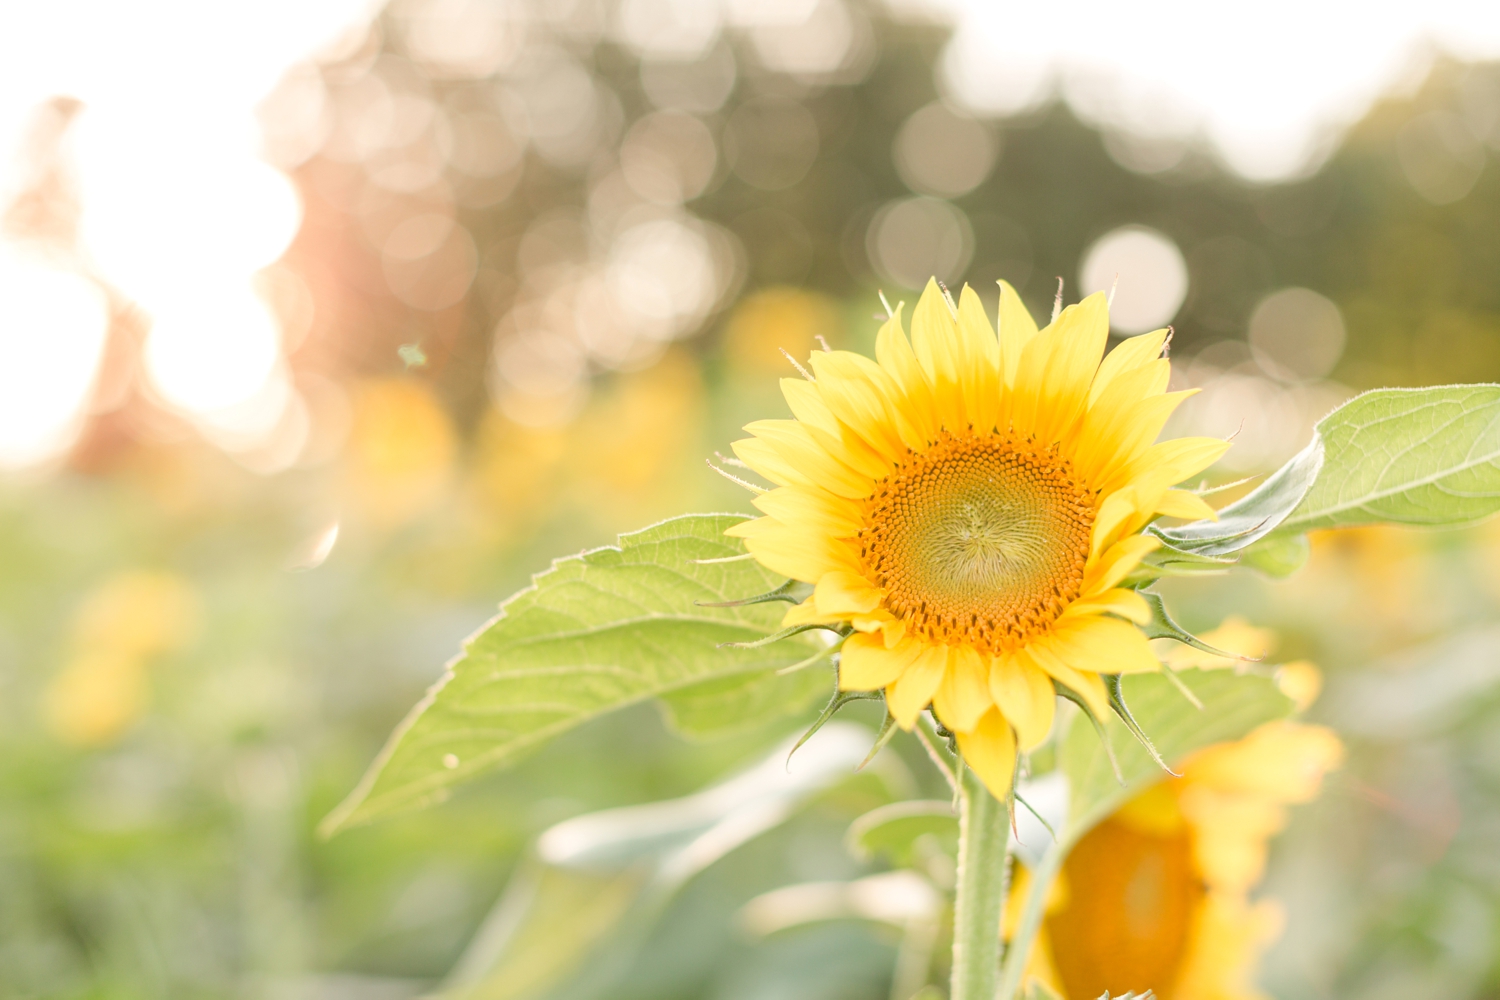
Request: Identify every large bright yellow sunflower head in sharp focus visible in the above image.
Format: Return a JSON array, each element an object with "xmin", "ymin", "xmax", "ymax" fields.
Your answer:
[{"xmin": 729, "ymin": 282, "xmax": 1229, "ymax": 796}]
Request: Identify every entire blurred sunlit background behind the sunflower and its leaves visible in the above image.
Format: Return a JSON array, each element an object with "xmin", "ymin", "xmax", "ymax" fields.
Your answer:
[{"xmin": 0, "ymin": 0, "xmax": 1500, "ymax": 1000}]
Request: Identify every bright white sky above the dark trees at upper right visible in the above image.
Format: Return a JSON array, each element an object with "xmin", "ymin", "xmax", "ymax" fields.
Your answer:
[{"xmin": 918, "ymin": 0, "xmax": 1500, "ymax": 180}]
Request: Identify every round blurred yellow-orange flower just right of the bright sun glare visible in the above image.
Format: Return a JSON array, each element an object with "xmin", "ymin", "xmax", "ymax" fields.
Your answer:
[{"xmin": 345, "ymin": 378, "xmax": 458, "ymax": 526}]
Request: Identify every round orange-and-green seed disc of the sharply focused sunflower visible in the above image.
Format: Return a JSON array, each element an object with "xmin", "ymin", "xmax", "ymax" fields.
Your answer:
[{"xmin": 860, "ymin": 432, "xmax": 1094, "ymax": 652}]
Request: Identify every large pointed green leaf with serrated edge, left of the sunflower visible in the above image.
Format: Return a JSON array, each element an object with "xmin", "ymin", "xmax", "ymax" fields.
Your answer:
[{"xmin": 321, "ymin": 514, "xmax": 821, "ymax": 835}]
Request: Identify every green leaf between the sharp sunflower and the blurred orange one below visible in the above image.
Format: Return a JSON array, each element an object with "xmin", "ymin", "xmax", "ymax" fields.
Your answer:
[{"xmin": 1059, "ymin": 670, "xmax": 1293, "ymax": 843}]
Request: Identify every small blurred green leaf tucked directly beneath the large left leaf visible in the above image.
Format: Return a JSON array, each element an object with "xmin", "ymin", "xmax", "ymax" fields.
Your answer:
[{"xmin": 662, "ymin": 649, "xmax": 834, "ymax": 742}]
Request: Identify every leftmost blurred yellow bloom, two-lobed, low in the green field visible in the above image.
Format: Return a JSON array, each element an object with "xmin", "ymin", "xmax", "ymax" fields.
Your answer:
[{"xmin": 42, "ymin": 571, "xmax": 198, "ymax": 747}]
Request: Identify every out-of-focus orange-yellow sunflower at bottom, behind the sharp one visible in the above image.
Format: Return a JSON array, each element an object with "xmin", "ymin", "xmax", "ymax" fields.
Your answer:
[{"xmin": 1007, "ymin": 710, "xmax": 1343, "ymax": 1000}]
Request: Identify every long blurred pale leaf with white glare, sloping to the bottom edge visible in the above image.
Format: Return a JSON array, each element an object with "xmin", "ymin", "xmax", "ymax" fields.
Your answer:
[{"xmin": 443, "ymin": 723, "xmax": 870, "ymax": 1000}]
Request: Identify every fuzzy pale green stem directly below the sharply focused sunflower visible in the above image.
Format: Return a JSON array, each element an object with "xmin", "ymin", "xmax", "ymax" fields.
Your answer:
[{"xmin": 948, "ymin": 768, "xmax": 1010, "ymax": 1000}]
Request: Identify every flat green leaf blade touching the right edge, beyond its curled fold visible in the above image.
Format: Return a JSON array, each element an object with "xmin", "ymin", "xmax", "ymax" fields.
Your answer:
[{"xmin": 1278, "ymin": 384, "xmax": 1500, "ymax": 534}]
